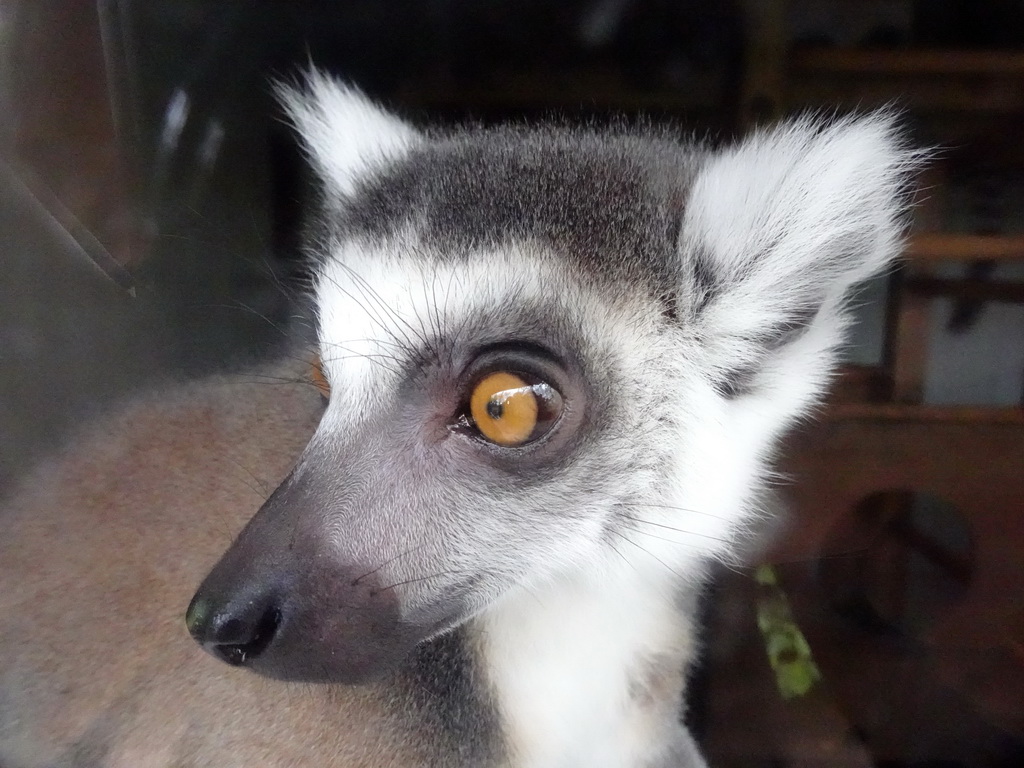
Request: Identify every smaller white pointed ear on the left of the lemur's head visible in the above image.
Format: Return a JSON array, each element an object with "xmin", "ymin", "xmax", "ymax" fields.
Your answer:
[{"xmin": 276, "ymin": 70, "xmax": 419, "ymax": 197}]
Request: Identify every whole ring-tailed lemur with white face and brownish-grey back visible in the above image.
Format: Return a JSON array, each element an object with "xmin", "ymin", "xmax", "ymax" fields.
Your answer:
[{"xmin": 0, "ymin": 74, "xmax": 916, "ymax": 768}]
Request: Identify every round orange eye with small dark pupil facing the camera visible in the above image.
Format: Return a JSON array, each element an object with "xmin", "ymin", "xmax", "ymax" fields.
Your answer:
[{"xmin": 469, "ymin": 371, "xmax": 562, "ymax": 446}]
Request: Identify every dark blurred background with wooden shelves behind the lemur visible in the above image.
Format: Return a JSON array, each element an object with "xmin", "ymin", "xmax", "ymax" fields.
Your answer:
[{"xmin": 0, "ymin": 0, "xmax": 1024, "ymax": 768}]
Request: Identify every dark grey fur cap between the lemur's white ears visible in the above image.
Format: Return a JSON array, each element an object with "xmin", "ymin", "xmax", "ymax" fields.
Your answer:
[{"xmin": 331, "ymin": 127, "xmax": 696, "ymax": 292}]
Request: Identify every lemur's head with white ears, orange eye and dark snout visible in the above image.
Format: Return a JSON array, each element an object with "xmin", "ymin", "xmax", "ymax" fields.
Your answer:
[{"xmin": 188, "ymin": 75, "xmax": 914, "ymax": 681}]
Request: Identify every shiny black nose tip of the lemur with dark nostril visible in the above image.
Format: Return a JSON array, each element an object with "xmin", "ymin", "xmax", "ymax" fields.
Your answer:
[{"xmin": 185, "ymin": 591, "xmax": 281, "ymax": 667}]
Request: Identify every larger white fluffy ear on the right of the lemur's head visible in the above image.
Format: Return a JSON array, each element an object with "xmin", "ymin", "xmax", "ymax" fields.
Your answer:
[{"xmin": 680, "ymin": 113, "xmax": 920, "ymax": 399}]
